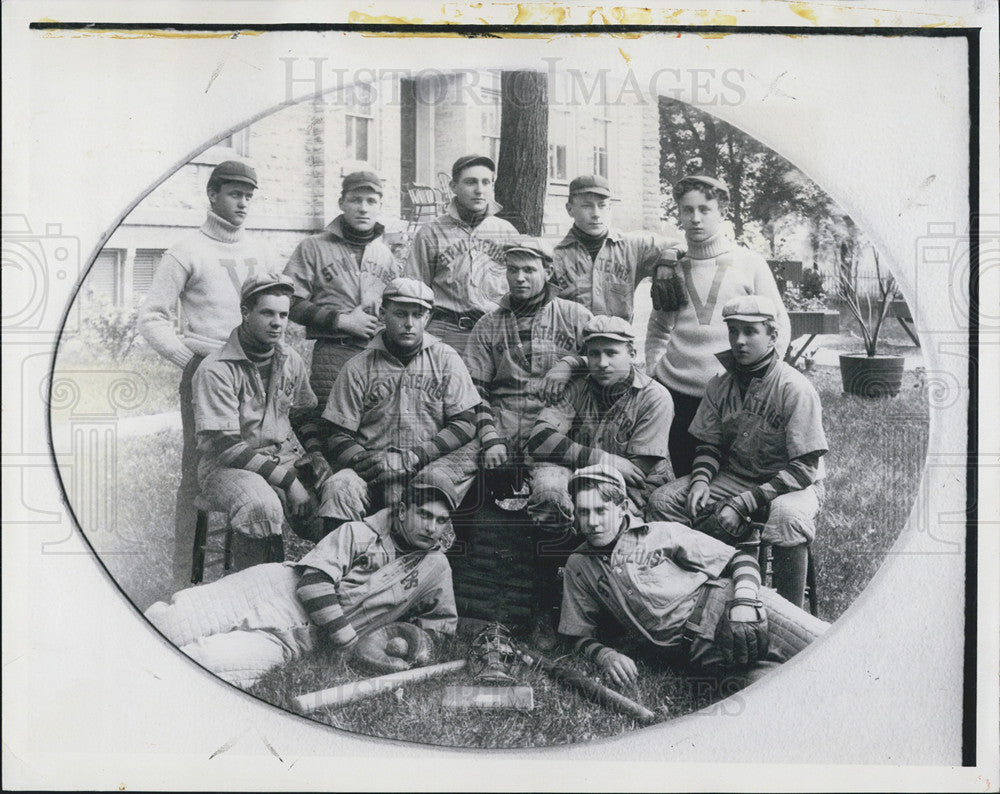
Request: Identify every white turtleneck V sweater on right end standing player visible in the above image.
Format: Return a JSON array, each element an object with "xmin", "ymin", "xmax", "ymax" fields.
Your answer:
[{"xmin": 646, "ymin": 232, "xmax": 791, "ymax": 397}]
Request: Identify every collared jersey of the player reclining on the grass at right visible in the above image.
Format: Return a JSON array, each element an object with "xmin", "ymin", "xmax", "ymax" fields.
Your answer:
[{"xmin": 559, "ymin": 516, "xmax": 736, "ymax": 647}]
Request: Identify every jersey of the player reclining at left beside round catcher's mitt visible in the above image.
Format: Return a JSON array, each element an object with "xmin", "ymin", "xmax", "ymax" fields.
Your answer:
[{"xmin": 286, "ymin": 508, "xmax": 457, "ymax": 628}]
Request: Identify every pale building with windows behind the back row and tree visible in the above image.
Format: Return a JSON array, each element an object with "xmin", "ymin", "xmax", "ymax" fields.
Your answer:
[{"xmin": 83, "ymin": 70, "xmax": 661, "ymax": 306}]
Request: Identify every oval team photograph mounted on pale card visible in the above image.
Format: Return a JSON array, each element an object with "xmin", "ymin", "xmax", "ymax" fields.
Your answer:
[{"xmin": 49, "ymin": 66, "xmax": 935, "ymax": 749}]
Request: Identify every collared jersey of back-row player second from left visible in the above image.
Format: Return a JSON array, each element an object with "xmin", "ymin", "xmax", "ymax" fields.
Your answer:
[{"xmin": 285, "ymin": 216, "xmax": 403, "ymax": 339}]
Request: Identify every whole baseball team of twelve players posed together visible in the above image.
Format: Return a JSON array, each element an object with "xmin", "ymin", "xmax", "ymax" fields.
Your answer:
[{"xmin": 139, "ymin": 155, "xmax": 828, "ymax": 700}]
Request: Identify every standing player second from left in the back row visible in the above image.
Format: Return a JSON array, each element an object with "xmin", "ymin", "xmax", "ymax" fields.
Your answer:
[{"xmin": 285, "ymin": 171, "xmax": 402, "ymax": 406}]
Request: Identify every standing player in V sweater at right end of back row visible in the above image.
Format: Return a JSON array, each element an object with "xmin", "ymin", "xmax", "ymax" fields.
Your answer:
[{"xmin": 646, "ymin": 175, "xmax": 791, "ymax": 477}]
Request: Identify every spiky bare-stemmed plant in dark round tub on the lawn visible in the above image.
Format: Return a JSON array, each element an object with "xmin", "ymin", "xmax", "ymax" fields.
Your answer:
[{"xmin": 839, "ymin": 251, "xmax": 903, "ymax": 397}]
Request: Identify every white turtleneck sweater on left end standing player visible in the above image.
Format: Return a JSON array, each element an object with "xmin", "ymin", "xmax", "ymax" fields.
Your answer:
[{"xmin": 138, "ymin": 210, "xmax": 280, "ymax": 368}]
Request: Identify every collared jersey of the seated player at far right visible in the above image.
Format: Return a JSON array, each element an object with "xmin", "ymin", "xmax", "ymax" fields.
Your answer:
[{"xmin": 689, "ymin": 351, "xmax": 827, "ymax": 483}]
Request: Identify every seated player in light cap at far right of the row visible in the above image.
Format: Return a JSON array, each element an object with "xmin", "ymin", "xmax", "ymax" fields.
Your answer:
[{"xmin": 646, "ymin": 295, "xmax": 827, "ymax": 606}]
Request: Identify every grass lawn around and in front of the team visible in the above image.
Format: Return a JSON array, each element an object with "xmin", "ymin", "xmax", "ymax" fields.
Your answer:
[{"xmin": 64, "ymin": 356, "xmax": 928, "ymax": 748}]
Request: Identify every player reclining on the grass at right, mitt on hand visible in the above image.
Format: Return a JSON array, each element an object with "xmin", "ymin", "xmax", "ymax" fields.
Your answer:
[{"xmin": 559, "ymin": 466, "xmax": 829, "ymax": 687}]
